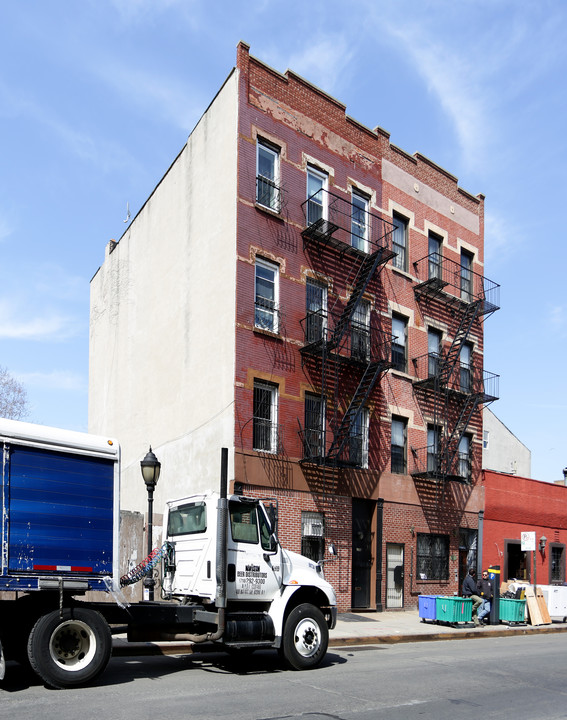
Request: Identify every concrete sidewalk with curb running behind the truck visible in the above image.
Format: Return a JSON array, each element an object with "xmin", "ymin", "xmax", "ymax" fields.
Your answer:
[{"xmin": 113, "ymin": 610, "xmax": 567, "ymax": 656}]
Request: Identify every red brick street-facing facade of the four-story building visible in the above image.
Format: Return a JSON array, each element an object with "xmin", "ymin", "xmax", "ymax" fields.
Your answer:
[{"xmin": 231, "ymin": 44, "xmax": 492, "ymax": 610}]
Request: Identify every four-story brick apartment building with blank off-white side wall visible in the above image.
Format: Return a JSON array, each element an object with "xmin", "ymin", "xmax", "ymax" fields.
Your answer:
[{"xmin": 89, "ymin": 43, "xmax": 498, "ymax": 610}]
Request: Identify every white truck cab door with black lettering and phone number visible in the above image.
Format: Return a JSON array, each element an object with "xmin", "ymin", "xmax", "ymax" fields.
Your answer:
[{"xmin": 227, "ymin": 498, "xmax": 282, "ymax": 602}]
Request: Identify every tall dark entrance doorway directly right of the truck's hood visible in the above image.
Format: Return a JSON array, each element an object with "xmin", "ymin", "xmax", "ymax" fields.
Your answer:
[{"xmin": 352, "ymin": 498, "xmax": 376, "ymax": 609}]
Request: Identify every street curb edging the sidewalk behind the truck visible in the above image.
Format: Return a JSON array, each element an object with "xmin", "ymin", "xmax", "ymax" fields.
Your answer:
[{"xmin": 112, "ymin": 625, "xmax": 567, "ymax": 657}]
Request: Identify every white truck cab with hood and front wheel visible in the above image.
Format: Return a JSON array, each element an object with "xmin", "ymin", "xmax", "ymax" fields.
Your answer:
[{"xmin": 163, "ymin": 492, "xmax": 337, "ymax": 669}]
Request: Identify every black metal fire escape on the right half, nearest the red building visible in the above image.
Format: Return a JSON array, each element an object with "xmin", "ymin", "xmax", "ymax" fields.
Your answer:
[{"xmin": 411, "ymin": 253, "xmax": 500, "ymax": 482}]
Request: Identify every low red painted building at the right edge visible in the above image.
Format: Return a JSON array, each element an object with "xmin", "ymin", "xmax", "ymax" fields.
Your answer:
[{"xmin": 482, "ymin": 470, "xmax": 567, "ymax": 585}]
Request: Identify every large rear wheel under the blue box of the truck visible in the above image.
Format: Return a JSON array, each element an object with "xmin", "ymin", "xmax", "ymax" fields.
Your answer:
[{"xmin": 28, "ymin": 608, "xmax": 112, "ymax": 689}]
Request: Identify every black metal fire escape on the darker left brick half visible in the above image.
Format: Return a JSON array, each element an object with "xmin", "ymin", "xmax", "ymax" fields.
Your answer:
[{"xmin": 300, "ymin": 186, "xmax": 395, "ymax": 466}]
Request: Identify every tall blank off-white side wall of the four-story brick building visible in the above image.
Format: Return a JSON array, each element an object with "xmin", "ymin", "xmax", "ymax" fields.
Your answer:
[{"xmin": 89, "ymin": 70, "xmax": 238, "ymax": 513}]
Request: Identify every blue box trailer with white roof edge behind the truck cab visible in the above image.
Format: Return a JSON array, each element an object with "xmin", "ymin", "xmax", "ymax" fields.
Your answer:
[{"xmin": 0, "ymin": 419, "xmax": 120, "ymax": 592}]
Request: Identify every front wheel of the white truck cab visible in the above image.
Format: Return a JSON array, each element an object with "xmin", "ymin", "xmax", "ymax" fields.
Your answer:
[{"xmin": 280, "ymin": 603, "xmax": 329, "ymax": 670}]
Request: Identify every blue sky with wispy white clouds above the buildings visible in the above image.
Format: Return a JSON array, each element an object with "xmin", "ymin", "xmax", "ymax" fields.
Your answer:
[{"xmin": 0, "ymin": 0, "xmax": 567, "ymax": 481}]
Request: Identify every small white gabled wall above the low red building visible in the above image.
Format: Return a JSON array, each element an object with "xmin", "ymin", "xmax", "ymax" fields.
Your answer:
[{"xmin": 482, "ymin": 408, "xmax": 532, "ymax": 478}]
